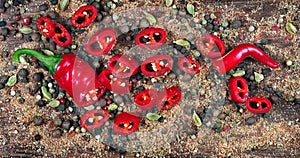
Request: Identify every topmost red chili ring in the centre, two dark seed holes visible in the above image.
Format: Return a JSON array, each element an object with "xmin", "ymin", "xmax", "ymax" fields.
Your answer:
[{"xmin": 135, "ymin": 27, "xmax": 167, "ymax": 49}]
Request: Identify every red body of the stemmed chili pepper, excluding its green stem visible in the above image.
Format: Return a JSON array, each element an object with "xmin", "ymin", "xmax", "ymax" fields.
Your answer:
[{"xmin": 52, "ymin": 54, "xmax": 106, "ymax": 107}]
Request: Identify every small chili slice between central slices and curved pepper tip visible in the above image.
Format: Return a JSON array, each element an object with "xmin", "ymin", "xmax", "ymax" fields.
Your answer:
[{"xmin": 178, "ymin": 57, "xmax": 200, "ymax": 75}]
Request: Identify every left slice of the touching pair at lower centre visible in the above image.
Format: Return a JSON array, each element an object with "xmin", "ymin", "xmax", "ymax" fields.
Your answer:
[{"xmin": 134, "ymin": 89, "xmax": 158, "ymax": 110}]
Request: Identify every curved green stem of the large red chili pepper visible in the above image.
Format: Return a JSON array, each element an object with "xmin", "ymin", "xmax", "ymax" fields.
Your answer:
[{"xmin": 12, "ymin": 48, "xmax": 62, "ymax": 74}]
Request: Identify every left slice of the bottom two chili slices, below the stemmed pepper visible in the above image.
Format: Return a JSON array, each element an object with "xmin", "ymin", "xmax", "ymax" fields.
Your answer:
[{"xmin": 79, "ymin": 110, "xmax": 110, "ymax": 130}]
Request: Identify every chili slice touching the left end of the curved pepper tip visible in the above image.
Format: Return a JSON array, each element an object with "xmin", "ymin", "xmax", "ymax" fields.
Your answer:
[{"xmin": 196, "ymin": 34, "xmax": 226, "ymax": 59}]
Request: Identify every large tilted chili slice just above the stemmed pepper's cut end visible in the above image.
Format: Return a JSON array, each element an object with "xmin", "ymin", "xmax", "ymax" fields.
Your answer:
[{"xmin": 85, "ymin": 28, "xmax": 117, "ymax": 56}]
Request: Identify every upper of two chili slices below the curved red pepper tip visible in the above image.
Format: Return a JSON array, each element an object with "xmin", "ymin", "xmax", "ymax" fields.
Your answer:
[{"xmin": 228, "ymin": 77, "xmax": 249, "ymax": 103}]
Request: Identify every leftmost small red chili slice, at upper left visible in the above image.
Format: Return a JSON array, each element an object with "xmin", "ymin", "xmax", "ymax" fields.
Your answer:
[{"xmin": 37, "ymin": 16, "xmax": 55, "ymax": 38}]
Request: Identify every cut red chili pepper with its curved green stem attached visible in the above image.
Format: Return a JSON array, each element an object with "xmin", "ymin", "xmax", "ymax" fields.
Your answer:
[{"xmin": 12, "ymin": 48, "xmax": 106, "ymax": 107}]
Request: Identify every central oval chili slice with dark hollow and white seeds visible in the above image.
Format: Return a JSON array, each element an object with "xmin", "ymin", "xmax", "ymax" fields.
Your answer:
[{"xmin": 141, "ymin": 54, "xmax": 173, "ymax": 77}]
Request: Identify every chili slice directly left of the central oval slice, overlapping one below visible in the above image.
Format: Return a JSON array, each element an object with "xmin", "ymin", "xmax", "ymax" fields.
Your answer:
[{"xmin": 107, "ymin": 54, "xmax": 139, "ymax": 78}]
